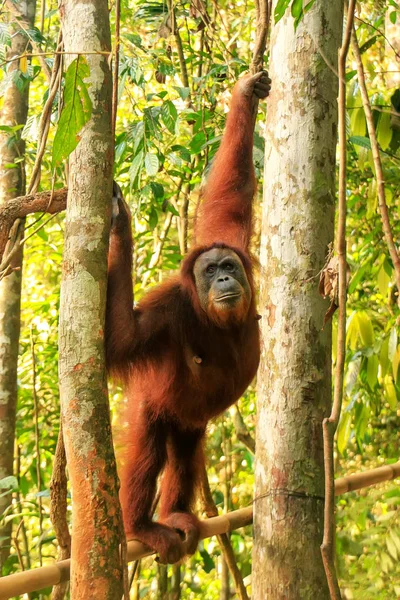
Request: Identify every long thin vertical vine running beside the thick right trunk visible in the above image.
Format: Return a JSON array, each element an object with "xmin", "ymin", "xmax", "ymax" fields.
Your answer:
[{"xmin": 321, "ymin": 0, "xmax": 355, "ymax": 600}]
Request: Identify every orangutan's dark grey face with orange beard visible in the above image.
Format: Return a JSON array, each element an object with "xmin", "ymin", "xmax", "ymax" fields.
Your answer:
[{"xmin": 193, "ymin": 248, "xmax": 251, "ymax": 321}]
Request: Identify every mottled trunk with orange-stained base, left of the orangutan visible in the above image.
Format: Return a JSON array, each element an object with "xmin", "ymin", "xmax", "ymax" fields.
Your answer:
[{"xmin": 59, "ymin": 0, "xmax": 123, "ymax": 600}]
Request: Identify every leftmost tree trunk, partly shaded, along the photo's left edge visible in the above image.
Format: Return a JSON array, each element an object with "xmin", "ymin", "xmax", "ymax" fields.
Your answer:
[{"xmin": 0, "ymin": 0, "xmax": 36, "ymax": 576}]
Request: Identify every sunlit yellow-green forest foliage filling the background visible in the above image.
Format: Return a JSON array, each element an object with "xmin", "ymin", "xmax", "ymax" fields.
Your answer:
[{"xmin": 0, "ymin": 0, "xmax": 400, "ymax": 600}]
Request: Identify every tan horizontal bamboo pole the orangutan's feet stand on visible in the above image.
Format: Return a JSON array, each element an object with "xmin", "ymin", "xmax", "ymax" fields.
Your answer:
[{"xmin": 0, "ymin": 461, "xmax": 400, "ymax": 600}]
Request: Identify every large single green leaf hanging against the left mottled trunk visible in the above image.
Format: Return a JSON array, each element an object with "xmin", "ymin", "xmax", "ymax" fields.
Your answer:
[{"xmin": 51, "ymin": 56, "xmax": 92, "ymax": 169}]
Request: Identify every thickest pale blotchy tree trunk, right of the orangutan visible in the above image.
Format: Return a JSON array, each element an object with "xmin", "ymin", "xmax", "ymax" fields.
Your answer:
[{"xmin": 252, "ymin": 0, "xmax": 343, "ymax": 600}]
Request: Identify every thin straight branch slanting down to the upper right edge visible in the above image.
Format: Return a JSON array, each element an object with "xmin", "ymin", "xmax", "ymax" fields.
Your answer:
[{"xmin": 351, "ymin": 27, "xmax": 400, "ymax": 307}]
